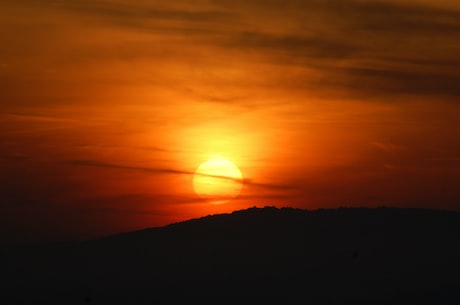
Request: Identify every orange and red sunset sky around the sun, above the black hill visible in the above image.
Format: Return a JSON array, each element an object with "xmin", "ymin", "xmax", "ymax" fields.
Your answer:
[{"xmin": 0, "ymin": 0, "xmax": 460, "ymax": 243}]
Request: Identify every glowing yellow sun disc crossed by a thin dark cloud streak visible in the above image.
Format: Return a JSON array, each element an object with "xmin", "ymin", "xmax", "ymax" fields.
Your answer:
[{"xmin": 193, "ymin": 158, "xmax": 243, "ymax": 204}]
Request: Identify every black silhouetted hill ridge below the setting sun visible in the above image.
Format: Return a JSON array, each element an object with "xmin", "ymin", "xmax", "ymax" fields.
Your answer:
[{"xmin": 1, "ymin": 207, "xmax": 460, "ymax": 305}]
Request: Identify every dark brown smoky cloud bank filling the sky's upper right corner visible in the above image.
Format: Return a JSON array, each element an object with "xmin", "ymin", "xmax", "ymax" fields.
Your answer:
[{"xmin": 220, "ymin": 1, "xmax": 460, "ymax": 97}]
